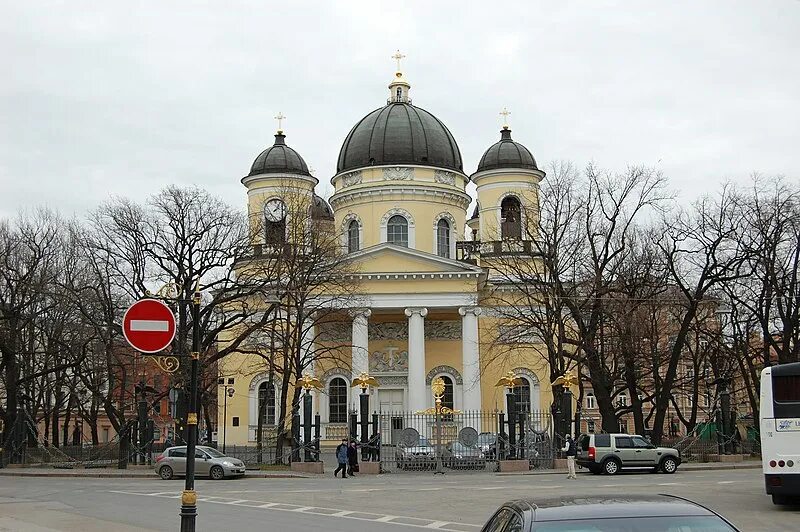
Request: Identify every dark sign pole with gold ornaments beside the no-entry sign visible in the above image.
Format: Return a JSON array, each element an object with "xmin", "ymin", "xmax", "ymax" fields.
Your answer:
[{"xmin": 181, "ymin": 288, "xmax": 200, "ymax": 532}]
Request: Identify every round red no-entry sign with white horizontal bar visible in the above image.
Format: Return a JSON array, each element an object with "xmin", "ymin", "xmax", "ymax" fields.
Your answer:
[{"xmin": 122, "ymin": 299, "xmax": 175, "ymax": 353}]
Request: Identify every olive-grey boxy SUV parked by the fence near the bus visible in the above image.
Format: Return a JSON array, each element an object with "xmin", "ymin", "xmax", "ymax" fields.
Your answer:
[{"xmin": 576, "ymin": 434, "xmax": 681, "ymax": 475}]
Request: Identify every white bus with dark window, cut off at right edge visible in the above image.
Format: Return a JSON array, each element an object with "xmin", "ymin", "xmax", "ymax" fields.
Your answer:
[{"xmin": 759, "ymin": 362, "xmax": 800, "ymax": 504}]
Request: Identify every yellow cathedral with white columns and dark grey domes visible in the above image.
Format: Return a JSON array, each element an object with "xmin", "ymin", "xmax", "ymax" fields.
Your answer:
[{"xmin": 217, "ymin": 57, "xmax": 552, "ymax": 445}]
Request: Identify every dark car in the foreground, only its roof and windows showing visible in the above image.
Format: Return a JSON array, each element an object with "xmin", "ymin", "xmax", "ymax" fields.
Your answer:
[{"xmin": 481, "ymin": 495, "xmax": 738, "ymax": 532}]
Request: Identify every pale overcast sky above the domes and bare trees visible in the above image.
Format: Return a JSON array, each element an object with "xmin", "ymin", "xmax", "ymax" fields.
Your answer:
[{"xmin": 0, "ymin": 0, "xmax": 800, "ymax": 216}]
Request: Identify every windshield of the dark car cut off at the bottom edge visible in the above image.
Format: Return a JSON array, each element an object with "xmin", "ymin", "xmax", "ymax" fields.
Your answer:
[{"xmin": 536, "ymin": 515, "xmax": 735, "ymax": 532}]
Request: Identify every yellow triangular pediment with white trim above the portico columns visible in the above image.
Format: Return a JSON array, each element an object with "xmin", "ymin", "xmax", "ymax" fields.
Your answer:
[{"xmin": 349, "ymin": 243, "xmax": 483, "ymax": 275}]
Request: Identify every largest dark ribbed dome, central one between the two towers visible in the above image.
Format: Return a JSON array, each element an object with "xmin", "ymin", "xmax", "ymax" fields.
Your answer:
[{"xmin": 336, "ymin": 102, "xmax": 463, "ymax": 172}]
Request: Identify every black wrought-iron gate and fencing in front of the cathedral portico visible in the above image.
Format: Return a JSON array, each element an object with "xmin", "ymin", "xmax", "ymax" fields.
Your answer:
[{"xmin": 378, "ymin": 411, "xmax": 555, "ymax": 472}]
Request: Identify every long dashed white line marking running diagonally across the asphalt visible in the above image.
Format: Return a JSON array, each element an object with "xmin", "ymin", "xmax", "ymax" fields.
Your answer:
[{"xmin": 109, "ymin": 488, "xmax": 481, "ymax": 532}]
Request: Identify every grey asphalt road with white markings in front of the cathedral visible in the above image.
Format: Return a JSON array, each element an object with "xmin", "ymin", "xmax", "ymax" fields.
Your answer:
[{"xmin": 0, "ymin": 470, "xmax": 800, "ymax": 532}]
